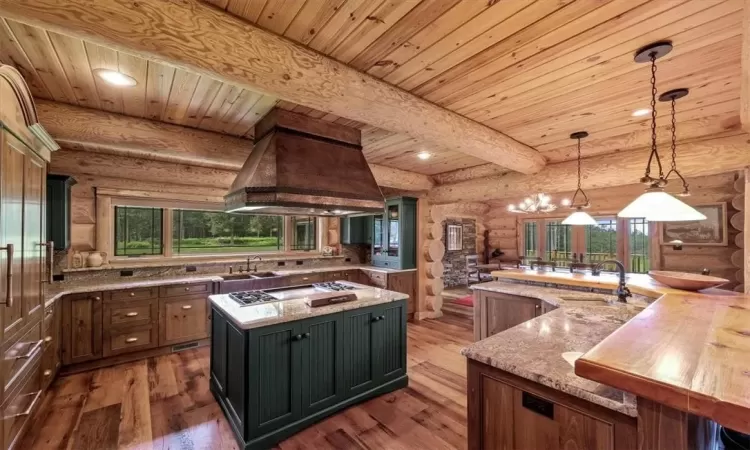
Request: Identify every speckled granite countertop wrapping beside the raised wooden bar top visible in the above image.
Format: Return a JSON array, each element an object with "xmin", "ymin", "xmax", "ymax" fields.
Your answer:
[{"xmin": 461, "ymin": 281, "xmax": 650, "ymax": 417}]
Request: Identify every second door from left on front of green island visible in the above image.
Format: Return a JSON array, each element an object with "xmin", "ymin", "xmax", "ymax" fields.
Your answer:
[{"xmin": 302, "ymin": 314, "xmax": 344, "ymax": 416}]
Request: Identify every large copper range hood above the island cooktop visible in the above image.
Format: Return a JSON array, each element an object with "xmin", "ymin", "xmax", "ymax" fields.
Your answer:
[{"xmin": 224, "ymin": 108, "xmax": 384, "ymax": 216}]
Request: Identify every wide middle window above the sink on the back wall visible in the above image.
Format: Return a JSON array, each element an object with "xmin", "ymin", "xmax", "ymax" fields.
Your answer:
[{"xmin": 172, "ymin": 209, "xmax": 284, "ymax": 255}]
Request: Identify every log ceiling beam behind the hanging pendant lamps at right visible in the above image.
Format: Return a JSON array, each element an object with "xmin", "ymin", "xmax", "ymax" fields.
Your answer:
[{"xmin": 429, "ymin": 133, "xmax": 750, "ymax": 203}]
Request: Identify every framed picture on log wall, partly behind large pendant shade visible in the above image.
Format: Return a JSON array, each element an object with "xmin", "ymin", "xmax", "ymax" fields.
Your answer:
[{"xmin": 661, "ymin": 202, "xmax": 729, "ymax": 246}]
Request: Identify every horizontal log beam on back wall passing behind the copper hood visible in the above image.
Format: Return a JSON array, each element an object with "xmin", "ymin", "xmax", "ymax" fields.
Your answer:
[{"xmin": 36, "ymin": 100, "xmax": 433, "ymax": 191}]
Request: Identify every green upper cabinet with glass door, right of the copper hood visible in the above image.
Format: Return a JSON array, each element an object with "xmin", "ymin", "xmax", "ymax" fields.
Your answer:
[{"xmin": 372, "ymin": 197, "xmax": 417, "ymax": 270}]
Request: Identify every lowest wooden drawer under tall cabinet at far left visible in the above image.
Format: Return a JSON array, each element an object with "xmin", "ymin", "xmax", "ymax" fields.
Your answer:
[{"xmin": 2, "ymin": 353, "xmax": 43, "ymax": 449}]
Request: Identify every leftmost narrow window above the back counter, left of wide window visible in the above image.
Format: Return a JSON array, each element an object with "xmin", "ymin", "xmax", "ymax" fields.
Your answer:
[{"xmin": 115, "ymin": 206, "xmax": 163, "ymax": 256}]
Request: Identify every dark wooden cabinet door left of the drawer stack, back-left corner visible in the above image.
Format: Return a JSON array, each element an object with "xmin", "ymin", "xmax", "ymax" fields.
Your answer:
[{"xmin": 62, "ymin": 293, "xmax": 102, "ymax": 364}]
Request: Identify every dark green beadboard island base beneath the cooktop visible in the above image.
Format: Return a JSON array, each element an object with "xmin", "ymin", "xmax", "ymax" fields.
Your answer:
[{"xmin": 210, "ymin": 300, "xmax": 408, "ymax": 450}]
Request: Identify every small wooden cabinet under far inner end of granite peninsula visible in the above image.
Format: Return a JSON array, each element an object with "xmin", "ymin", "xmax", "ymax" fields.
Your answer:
[{"xmin": 474, "ymin": 290, "xmax": 543, "ymax": 340}]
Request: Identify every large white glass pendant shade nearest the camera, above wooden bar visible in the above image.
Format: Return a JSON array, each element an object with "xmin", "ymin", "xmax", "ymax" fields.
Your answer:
[{"xmin": 617, "ymin": 189, "xmax": 706, "ymax": 222}]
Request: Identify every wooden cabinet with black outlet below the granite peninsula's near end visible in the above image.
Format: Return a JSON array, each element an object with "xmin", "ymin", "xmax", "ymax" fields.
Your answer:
[{"xmin": 468, "ymin": 360, "xmax": 637, "ymax": 450}]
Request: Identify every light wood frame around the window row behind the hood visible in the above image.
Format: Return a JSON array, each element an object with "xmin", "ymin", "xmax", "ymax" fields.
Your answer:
[{"xmin": 96, "ymin": 189, "xmax": 328, "ymax": 263}]
